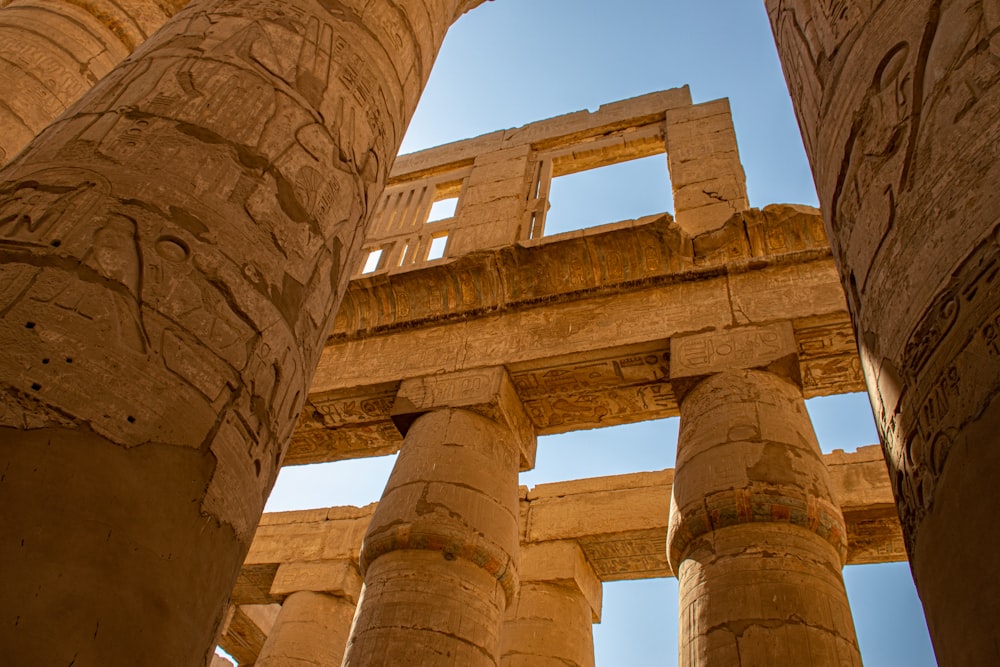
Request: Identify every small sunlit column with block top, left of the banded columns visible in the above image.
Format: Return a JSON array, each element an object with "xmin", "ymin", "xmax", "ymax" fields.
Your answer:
[{"xmin": 254, "ymin": 561, "xmax": 361, "ymax": 667}]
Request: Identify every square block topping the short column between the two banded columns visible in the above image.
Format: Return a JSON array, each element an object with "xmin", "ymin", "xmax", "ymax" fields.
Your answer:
[{"xmin": 520, "ymin": 541, "xmax": 604, "ymax": 623}]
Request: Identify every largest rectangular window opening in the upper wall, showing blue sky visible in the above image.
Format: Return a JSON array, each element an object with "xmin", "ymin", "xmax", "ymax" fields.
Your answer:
[{"xmin": 545, "ymin": 153, "xmax": 674, "ymax": 236}]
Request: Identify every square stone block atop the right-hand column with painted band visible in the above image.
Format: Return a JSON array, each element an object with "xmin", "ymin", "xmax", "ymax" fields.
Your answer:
[{"xmin": 670, "ymin": 322, "xmax": 802, "ymax": 397}]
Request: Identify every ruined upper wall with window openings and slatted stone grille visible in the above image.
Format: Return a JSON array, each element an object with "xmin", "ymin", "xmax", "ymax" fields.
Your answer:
[{"xmin": 355, "ymin": 86, "xmax": 749, "ymax": 274}]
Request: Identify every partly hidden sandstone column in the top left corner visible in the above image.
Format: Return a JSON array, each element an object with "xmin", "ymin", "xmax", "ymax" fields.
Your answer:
[{"xmin": 0, "ymin": 0, "xmax": 187, "ymax": 165}]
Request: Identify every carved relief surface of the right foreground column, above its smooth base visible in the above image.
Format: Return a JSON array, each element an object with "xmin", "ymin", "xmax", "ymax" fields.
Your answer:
[{"xmin": 769, "ymin": 0, "xmax": 1000, "ymax": 560}]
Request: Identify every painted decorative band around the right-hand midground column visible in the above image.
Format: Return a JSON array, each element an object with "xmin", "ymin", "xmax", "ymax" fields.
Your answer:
[{"xmin": 667, "ymin": 489, "xmax": 847, "ymax": 566}]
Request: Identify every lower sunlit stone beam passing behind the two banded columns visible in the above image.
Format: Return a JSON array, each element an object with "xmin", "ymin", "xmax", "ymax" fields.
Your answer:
[{"xmin": 233, "ymin": 446, "xmax": 906, "ymax": 604}]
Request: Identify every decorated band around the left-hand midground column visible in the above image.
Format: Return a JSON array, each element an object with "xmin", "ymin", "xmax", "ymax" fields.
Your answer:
[{"xmin": 360, "ymin": 524, "xmax": 518, "ymax": 604}]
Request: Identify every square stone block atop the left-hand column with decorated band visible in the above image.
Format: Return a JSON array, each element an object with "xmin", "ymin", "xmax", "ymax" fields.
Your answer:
[{"xmin": 390, "ymin": 366, "xmax": 538, "ymax": 470}]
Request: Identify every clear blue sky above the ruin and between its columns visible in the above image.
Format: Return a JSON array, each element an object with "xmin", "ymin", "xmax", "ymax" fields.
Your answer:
[{"xmin": 268, "ymin": 0, "xmax": 936, "ymax": 667}]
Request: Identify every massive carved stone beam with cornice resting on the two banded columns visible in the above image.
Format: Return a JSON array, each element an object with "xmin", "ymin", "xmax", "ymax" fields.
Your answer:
[{"xmin": 284, "ymin": 206, "xmax": 864, "ymax": 465}]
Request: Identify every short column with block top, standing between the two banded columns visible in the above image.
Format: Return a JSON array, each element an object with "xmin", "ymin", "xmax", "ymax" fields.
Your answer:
[{"xmin": 500, "ymin": 542, "xmax": 602, "ymax": 667}]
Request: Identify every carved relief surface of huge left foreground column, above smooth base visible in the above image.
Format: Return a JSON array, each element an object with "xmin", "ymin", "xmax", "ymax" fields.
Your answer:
[{"xmin": 0, "ymin": 0, "xmax": 472, "ymax": 548}]
